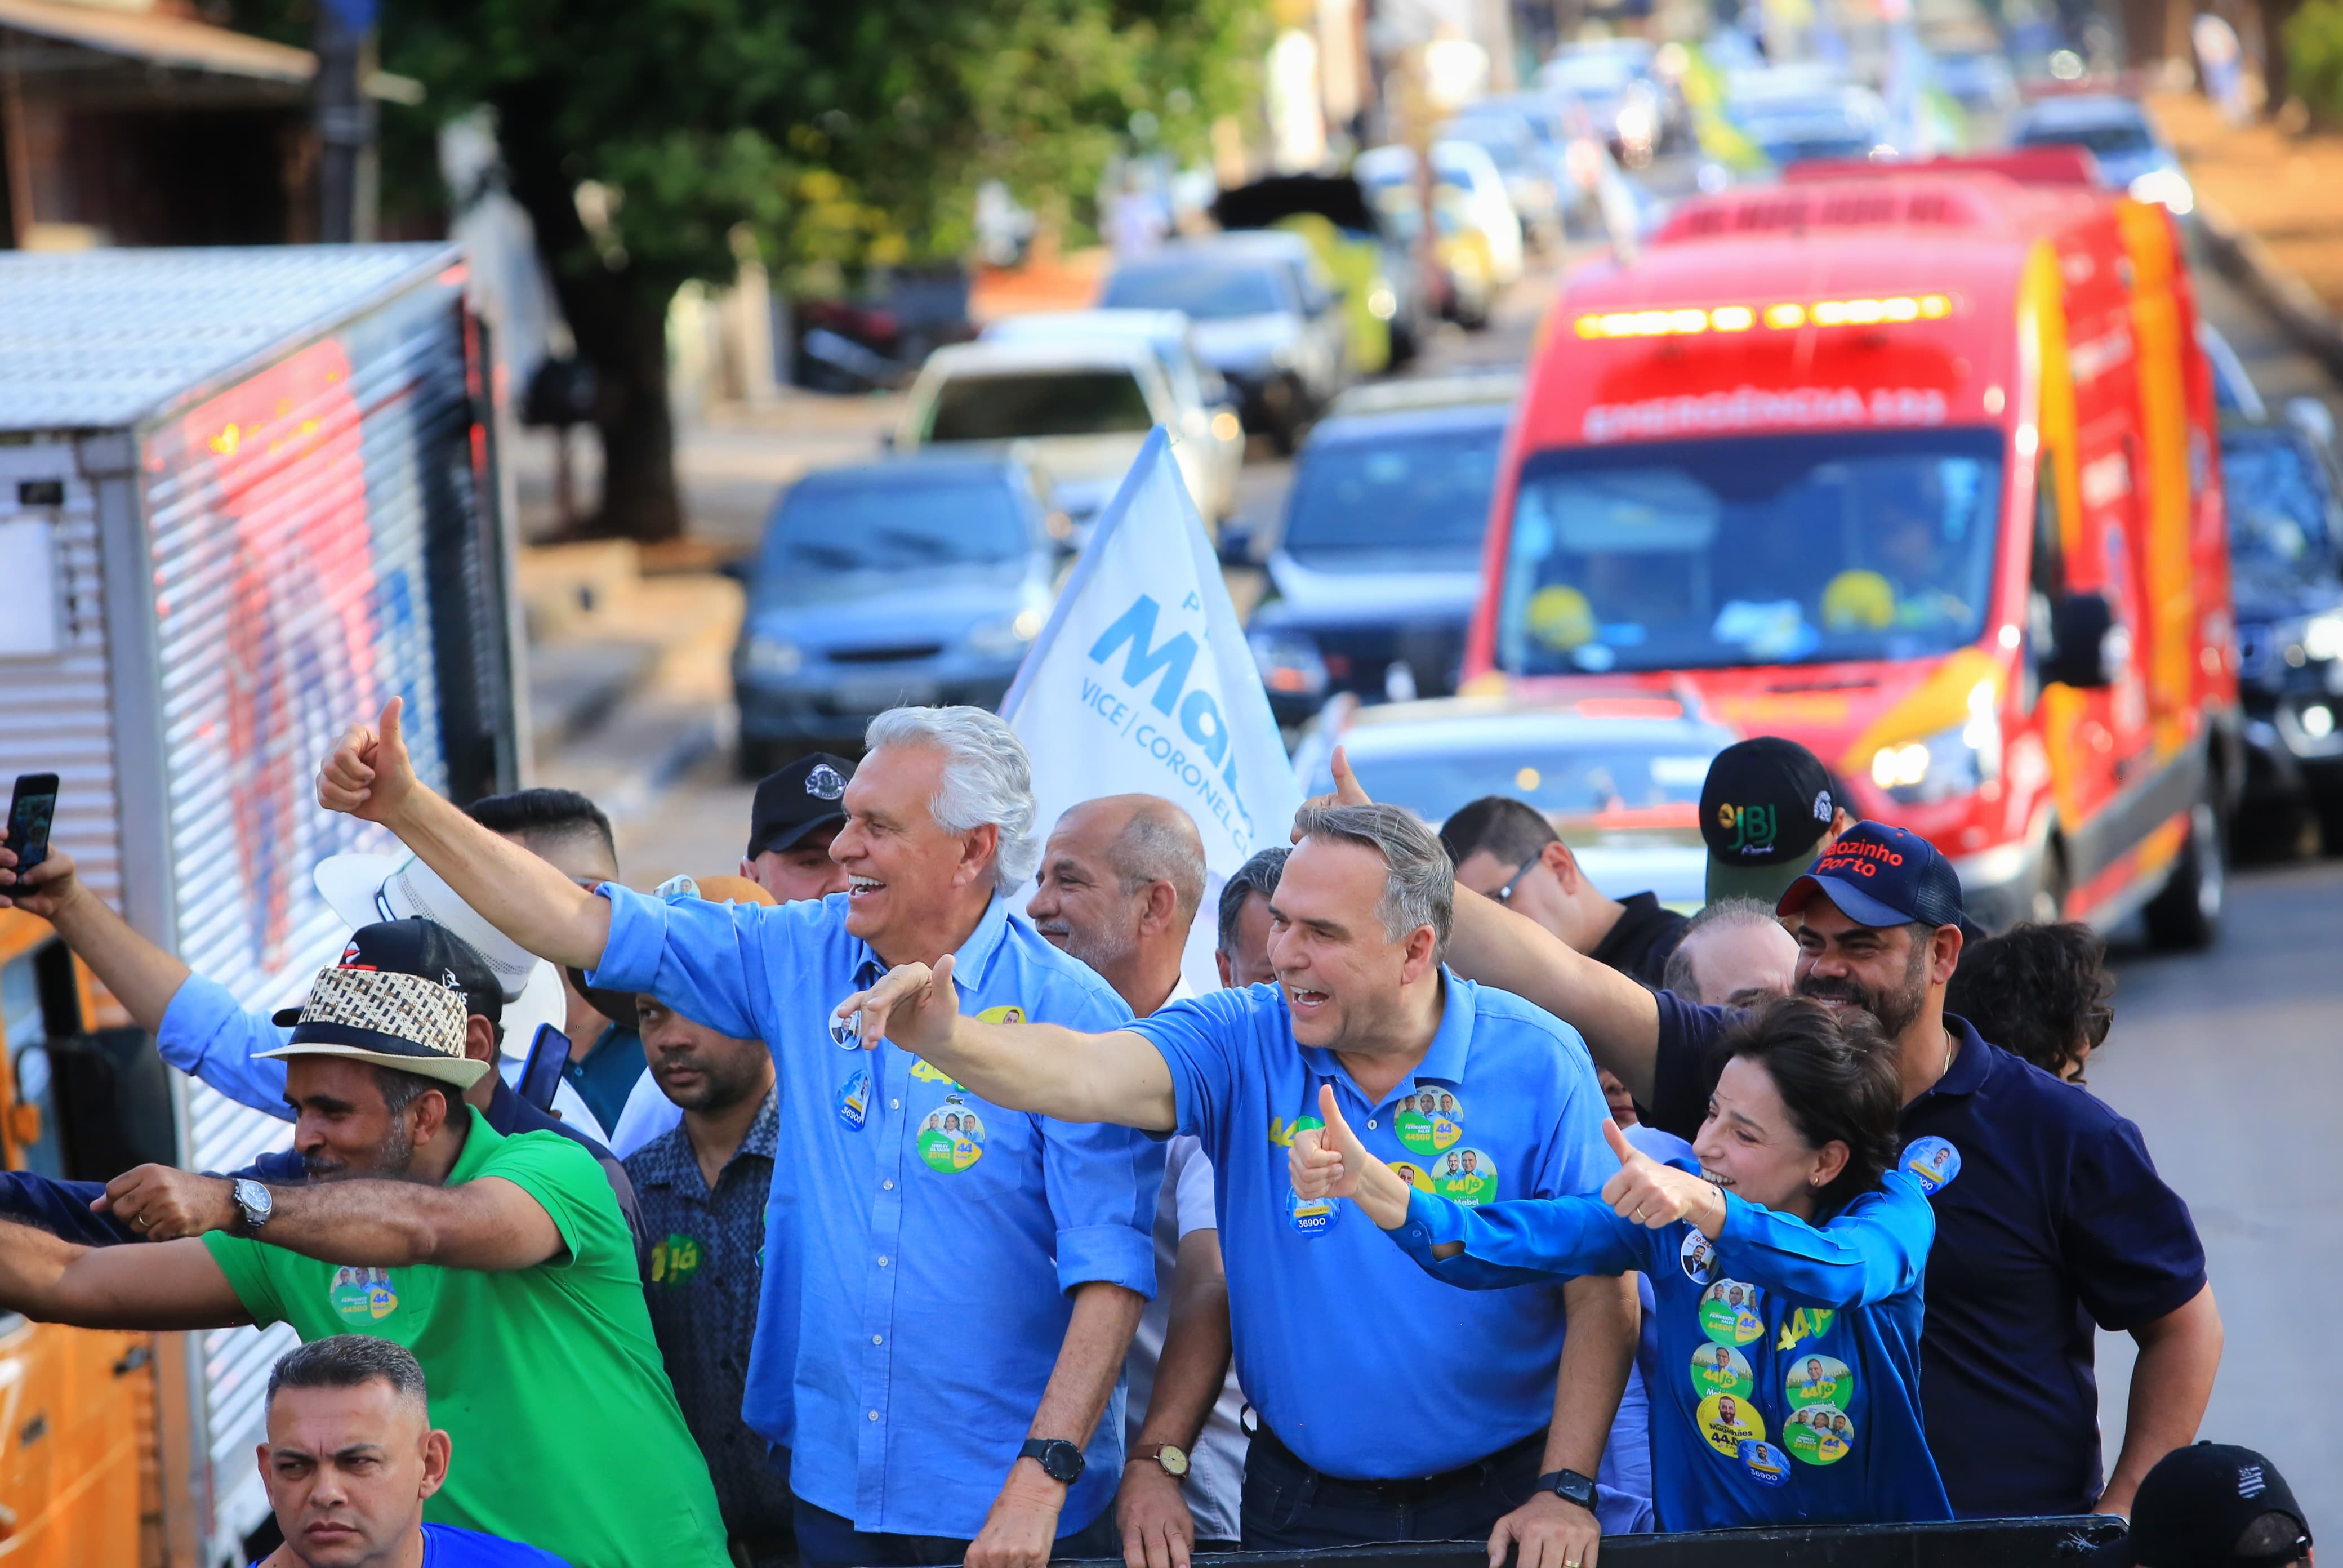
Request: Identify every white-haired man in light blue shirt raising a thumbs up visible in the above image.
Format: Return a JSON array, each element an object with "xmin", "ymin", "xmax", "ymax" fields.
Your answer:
[{"xmin": 319, "ymin": 703, "xmax": 1162, "ymax": 1568}]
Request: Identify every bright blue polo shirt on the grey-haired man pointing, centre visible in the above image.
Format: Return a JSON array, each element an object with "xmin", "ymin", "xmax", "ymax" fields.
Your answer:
[{"xmin": 1125, "ymin": 970, "xmax": 1619, "ymax": 1479}]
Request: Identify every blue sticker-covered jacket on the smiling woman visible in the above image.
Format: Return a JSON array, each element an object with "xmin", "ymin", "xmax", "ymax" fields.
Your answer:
[{"xmin": 1392, "ymin": 1170, "xmax": 1952, "ymax": 1530}]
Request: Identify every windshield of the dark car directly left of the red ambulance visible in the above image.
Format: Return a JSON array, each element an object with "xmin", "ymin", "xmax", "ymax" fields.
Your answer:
[{"xmin": 1284, "ymin": 424, "xmax": 1504, "ymax": 569}]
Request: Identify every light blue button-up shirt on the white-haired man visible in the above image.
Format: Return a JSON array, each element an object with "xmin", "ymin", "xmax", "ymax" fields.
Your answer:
[{"xmin": 593, "ymin": 886, "xmax": 1162, "ymax": 1538}]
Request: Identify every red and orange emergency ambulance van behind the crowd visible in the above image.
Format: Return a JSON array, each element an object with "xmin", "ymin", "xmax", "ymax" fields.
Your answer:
[{"xmin": 1464, "ymin": 148, "xmax": 2242, "ymax": 947}]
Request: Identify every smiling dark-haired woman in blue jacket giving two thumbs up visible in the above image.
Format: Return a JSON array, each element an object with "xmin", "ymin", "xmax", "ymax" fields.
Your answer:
[{"xmin": 1291, "ymin": 996, "xmax": 1952, "ymax": 1530}]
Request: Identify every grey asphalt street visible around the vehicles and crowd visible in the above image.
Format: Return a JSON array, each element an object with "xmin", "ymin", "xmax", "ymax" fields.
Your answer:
[{"xmin": 599, "ymin": 201, "xmax": 2343, "ymax": 1528}]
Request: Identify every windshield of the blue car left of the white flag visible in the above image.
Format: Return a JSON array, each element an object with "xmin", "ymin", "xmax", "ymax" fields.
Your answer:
[{"xmin": 759, "ymin": 478, "xmax": 1034, "ymax": 586}]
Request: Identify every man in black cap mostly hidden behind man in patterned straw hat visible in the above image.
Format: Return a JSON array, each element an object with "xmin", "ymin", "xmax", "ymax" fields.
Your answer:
[{"xmin": 0, "ymin": 919, "xmax": 642, "ymax": 1247}]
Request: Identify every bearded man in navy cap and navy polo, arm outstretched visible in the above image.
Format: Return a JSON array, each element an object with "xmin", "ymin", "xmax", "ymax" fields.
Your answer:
[{"xmin": 1335, "ymin": 755, "xmax": 2221, "ymax": 1519}]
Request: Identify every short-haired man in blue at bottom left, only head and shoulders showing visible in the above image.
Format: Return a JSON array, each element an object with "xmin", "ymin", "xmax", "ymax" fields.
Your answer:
[{"xmin": 253, "ymin": 1334, "xmax": 565, "ymax": 1568}]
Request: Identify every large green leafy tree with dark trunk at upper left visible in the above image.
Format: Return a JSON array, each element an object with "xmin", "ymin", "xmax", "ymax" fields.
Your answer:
[{"xmin": 330, "ymin": 0, "xmax": 1268, "ymax": 539}]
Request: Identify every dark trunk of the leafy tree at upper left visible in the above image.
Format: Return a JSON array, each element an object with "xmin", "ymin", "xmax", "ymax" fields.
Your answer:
[{"xmin": 497, "ymin": 103, "xmax": 684, "ymax": 544}]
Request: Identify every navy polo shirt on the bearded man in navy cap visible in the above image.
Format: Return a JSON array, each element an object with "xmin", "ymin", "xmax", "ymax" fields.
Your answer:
[{"xmin": 1652, "ymin": 991, "xmax": 2205, "ymax": 1519}]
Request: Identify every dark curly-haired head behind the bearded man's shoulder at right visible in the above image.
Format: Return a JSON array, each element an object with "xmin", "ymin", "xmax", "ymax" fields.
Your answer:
[{"xmin": 1945, "ymin": 921, "xmax": 2115, "ymax": 1085}]
